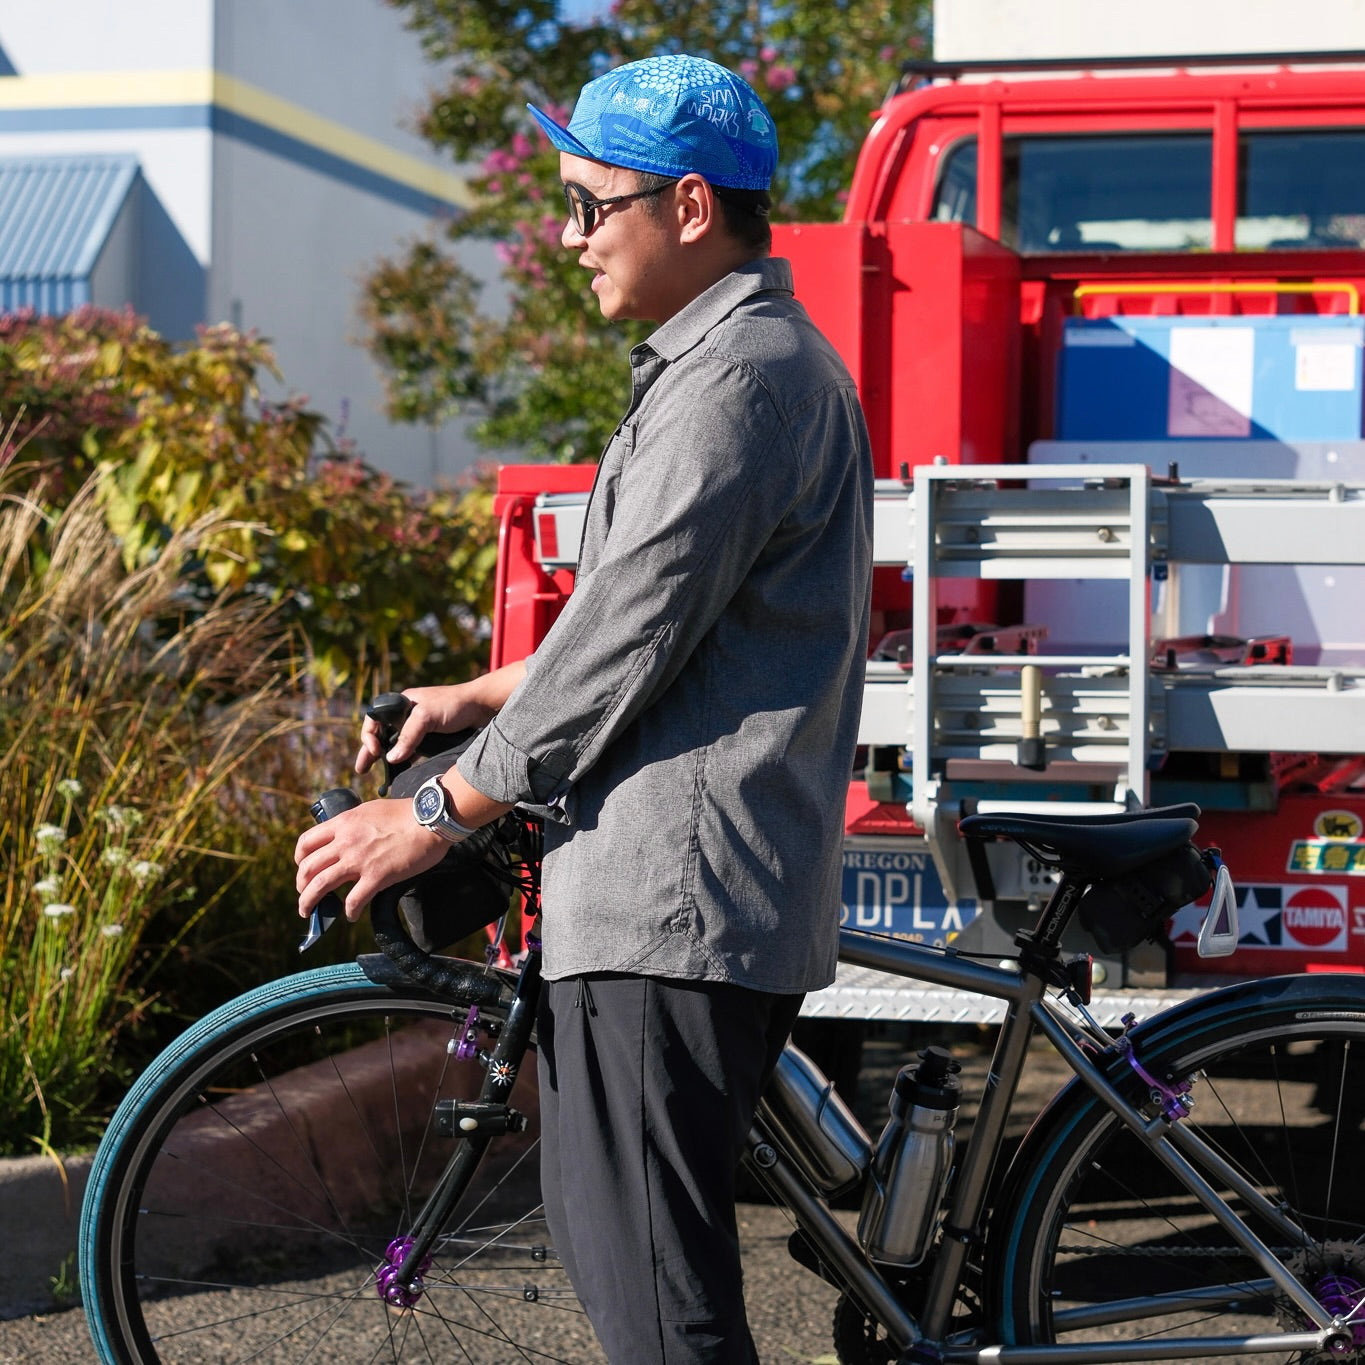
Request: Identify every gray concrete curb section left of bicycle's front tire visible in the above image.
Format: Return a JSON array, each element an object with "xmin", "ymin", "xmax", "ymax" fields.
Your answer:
[{"xmin": 0, "ymin": 1156, "xmax": 91, "ymax": 1320}]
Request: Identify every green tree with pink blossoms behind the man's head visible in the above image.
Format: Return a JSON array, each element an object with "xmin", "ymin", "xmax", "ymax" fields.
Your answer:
[{"xmin": 364, "ymin": 0, "xmax": 930, "ymax": 460}]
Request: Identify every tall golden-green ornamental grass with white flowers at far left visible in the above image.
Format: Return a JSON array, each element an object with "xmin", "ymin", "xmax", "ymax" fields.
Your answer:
[{"xmin": 0, "ymin": 461, "xmax": 300, "ymax": 1152}]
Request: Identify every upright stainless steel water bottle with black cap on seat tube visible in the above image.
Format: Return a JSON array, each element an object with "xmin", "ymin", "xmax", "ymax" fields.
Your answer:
[{"xmin": 857, "ymin": 1047, "xmax": 962, "ymax": 1265}]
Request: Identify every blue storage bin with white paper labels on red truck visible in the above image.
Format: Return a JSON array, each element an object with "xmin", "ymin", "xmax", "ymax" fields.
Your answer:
[{"xmin": 1055, "ymin": 314, "xmax": 1365, "ymax": 441}]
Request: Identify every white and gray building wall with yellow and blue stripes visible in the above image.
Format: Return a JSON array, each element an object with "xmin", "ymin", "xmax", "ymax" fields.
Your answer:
[{"xmin": 0, "ymin": 0, "xmax": 497, "ymax": 483}]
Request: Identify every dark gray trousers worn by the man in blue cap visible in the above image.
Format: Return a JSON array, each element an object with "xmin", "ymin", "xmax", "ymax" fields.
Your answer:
[{"xmin": 536, "ymin": 973, "xmax": 801, "ymax": 1365}]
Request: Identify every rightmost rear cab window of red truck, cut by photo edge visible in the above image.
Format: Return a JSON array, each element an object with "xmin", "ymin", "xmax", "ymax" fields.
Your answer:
[{"xmin": 1234, "ymin": 128, "xmax": 1365, "ymax": 251}]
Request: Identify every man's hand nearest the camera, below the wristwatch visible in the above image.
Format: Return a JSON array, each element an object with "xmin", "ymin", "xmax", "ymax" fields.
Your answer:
[{"xmin": 293, "ymin": 800, "xmax": 450, "ymax": 920}]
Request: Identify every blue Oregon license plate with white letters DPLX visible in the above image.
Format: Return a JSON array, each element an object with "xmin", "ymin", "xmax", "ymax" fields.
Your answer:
[{"xmin": 839, "ymin": 848, "xmax": 980, "ymax": 945}]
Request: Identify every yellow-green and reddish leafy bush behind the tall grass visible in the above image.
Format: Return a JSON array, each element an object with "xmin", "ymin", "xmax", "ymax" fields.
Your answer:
[{"xmin": 0, "ymin": 308, "xmax": 495, "ymax": 692}]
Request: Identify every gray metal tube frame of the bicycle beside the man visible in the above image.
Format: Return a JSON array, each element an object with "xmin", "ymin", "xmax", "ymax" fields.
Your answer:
[{"xmin": 747, "ymin": 900, "xmax": 1348, "ymax": 1365}]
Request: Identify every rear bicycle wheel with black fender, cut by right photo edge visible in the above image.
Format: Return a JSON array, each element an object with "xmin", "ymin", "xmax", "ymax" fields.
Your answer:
[{"xmin": 990, "ymin": 976, "xmax": 1365, "ymax": 1361}]
